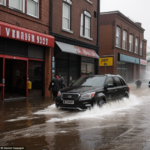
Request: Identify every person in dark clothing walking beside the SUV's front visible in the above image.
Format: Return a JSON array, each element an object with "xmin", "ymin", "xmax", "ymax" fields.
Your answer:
[{"xmin": 49, "ymin": 75, "xmax": 61, "ymax": 101}]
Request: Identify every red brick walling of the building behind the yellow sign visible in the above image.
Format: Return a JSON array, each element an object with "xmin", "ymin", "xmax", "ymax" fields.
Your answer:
[{"xmin": 99, "ymin": 13, "xmax": 147, "ymax": 74}]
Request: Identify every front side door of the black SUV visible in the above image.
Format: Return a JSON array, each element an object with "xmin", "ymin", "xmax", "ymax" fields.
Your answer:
[{"xmin": 105, "ymin": 77, "xmax": 116, "ymax": 101}]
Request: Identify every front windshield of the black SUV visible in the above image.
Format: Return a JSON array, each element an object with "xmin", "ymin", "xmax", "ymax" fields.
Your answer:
[{"xmin": 72, "ymin": 76, "xmax": 106, "ymax": 87}]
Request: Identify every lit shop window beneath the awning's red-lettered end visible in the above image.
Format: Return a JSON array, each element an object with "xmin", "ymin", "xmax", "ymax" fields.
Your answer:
[{"xmin": 81, "ymin": 62, "xmax": 94, "ymax": 76}]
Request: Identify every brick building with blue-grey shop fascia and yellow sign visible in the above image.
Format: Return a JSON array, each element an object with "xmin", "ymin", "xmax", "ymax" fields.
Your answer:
[{"xmin": 99, "ymin": 11, "xmax": 147, "ymax": 82}]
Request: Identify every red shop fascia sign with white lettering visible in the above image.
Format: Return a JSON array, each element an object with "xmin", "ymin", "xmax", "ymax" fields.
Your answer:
[{"xmin": 0, "ymin": 22, "xmax": 55, "ymax": 47}]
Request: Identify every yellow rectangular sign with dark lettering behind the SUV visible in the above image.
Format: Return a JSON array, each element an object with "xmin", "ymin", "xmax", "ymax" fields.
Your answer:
[{"xmin": 99, "ymin": 57, "xmax": 113, "ymax": 66}]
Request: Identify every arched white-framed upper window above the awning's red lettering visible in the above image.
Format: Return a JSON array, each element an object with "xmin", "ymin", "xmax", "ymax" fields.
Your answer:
[{"xmin": 80, "ymin": 11, "xmax": 91, "ymax": 38}]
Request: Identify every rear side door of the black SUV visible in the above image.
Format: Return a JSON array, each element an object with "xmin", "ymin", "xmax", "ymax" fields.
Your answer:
[{"xmin": 114, "ymin": 76, "xmax": 124, "ymax": 100}]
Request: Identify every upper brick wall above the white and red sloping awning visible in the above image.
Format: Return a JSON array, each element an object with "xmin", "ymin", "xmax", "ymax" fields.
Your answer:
[{"xmin": 52, "ymin": 0, "xmax": 97, "ymax": 45}]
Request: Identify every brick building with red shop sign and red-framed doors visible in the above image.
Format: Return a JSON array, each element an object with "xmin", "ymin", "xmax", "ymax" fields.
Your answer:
[{"xmin": 0, "ymin": 0, "xmax": 54, "ymax": 99}]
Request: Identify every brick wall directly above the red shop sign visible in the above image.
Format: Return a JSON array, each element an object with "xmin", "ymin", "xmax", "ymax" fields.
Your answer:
[{"xmin": 0, "ymin": 0, "xmax": 50, "ymax": 34}]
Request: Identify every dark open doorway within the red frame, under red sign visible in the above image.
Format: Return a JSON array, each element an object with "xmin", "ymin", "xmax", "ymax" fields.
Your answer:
[{"xmin": 4, "ymin": 59, "xmax": 27, "ymax": 99}]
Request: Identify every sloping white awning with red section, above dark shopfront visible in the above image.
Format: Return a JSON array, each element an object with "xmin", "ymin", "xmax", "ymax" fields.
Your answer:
[{"xmin": 56, "ymin": 41, "xmax": 99, "ymax": 59}]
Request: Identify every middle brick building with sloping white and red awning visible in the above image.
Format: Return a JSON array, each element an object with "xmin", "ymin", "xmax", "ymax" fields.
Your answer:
[{"xmin": 50, "ymin": 0, "xmax": 99, "ymax": 85}]
